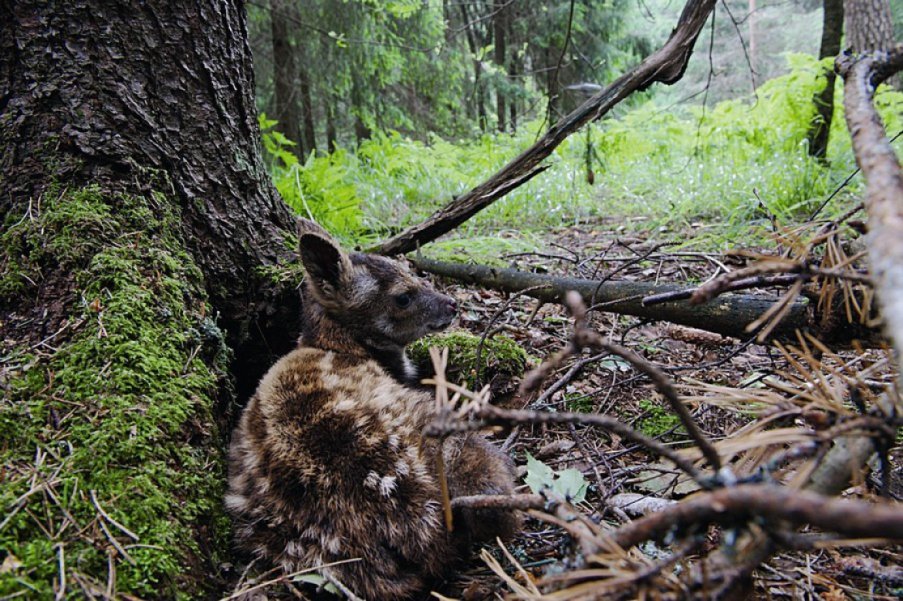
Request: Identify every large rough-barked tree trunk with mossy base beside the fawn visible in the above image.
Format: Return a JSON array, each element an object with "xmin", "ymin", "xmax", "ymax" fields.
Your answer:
[{"xmin": 0, "ymin": 0, "xmax": 299, "ymax": 598}]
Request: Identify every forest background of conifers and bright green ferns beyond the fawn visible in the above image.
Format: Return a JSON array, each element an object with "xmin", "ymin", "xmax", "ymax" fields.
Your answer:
[{"xmin": 249, "ymin": 0, "xmax": 903, "ymax": 255}]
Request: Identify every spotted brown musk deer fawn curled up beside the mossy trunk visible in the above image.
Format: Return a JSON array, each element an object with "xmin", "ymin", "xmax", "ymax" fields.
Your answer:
[{"xmin": 226, "ymin": 220, "xmax": 517, "ymax": 600}]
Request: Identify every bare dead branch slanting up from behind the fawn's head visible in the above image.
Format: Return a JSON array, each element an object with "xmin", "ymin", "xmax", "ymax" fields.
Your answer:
[{"xmin": 370, "ymin": 0, "xmax": 715, "ymax": 255}]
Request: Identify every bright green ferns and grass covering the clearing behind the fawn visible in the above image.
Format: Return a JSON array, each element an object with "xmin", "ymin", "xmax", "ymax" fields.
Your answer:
[{"xmin": 264, "ymin": 54, "xmax": 903, "ymax": 257}]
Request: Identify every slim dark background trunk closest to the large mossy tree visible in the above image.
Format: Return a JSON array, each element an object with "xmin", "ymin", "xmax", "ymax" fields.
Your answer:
[{"xmin": 270, "ymin": 0, "xmax": 307, "ymax": 157}]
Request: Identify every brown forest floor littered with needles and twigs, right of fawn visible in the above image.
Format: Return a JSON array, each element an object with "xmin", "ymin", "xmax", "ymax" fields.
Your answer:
[{"xmin": 222, "ymin": 219, "xmax": 903, "ymax": 601}]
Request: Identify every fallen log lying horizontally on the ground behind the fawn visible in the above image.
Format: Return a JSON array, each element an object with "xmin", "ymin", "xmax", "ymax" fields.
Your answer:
[{"xmin": 411, "ymin": 256, "xmax": 880, "ymax": 343}]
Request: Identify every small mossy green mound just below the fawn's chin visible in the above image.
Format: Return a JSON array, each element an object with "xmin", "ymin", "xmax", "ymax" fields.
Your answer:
[{"xmin": 408, "ymin": 331, "xmax": 527, "ymax": 393}]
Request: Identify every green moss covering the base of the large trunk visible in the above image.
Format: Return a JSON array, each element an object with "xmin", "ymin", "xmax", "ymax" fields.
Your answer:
[{"xmin": 0, "ymin": 187, "xmax": 229, "ymax": 599}]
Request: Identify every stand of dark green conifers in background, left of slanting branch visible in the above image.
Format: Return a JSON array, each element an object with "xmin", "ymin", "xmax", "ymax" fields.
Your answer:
[{"xmin": 249, "ymin": 0, "xmax": 650, "ymax": 148}]
